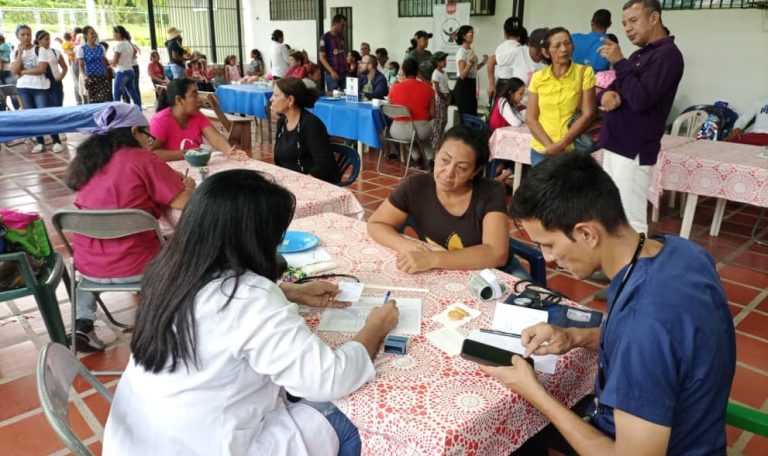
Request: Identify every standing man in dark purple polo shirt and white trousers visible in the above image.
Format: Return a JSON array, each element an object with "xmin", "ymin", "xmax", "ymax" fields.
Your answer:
[{"xmin": 599, "ymin": 0, "xmax": 683, "ymax": 233}]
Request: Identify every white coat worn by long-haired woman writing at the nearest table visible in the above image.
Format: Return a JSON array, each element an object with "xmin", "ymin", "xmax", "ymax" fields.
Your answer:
[{"xmin": 104, "ymin": 273, "xmax": 375, "ymax": 456}]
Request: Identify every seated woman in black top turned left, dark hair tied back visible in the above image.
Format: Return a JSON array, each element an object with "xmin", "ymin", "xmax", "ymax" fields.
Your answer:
[{"xmin": 272, "ymin": 78, "xmax": 341, "ymax": 184}]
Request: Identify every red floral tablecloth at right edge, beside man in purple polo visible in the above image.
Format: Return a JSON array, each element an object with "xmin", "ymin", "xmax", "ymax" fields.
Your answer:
[{"xmin": 648, "ymin": 141, "xmax": 768, "ymax": 207}]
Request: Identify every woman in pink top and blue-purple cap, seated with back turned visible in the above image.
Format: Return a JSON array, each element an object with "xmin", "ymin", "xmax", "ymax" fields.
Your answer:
[{"xmin": 66, "ymin": 104, "xmax": 195, "ymax": 351}]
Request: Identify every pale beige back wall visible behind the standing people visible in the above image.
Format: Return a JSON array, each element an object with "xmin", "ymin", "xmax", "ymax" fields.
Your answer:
[{"xmin": 243, "ymin": 0, "xmax": 768, "ymax": 119}]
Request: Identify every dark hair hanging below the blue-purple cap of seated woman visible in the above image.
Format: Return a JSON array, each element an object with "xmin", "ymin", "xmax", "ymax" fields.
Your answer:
[{"xmin": 65, "ymin": 127, "xmax": 141, "ymax": 191}]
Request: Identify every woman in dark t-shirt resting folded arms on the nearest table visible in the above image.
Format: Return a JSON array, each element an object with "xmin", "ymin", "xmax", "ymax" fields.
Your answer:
[{"xmin": 368, "ymin": 126, "xmax": 527, "ymax": 275}]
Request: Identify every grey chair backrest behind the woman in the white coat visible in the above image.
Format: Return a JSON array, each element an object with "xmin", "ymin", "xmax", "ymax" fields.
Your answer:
[{"xmin": 37, "ymin": 343, "xmax": 112, "ymax": 455}]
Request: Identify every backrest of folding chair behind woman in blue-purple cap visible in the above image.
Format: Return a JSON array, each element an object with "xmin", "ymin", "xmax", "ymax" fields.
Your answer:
[{"xmin": 52, "ymin": 209, "xmax": 165, "ymax": 255}]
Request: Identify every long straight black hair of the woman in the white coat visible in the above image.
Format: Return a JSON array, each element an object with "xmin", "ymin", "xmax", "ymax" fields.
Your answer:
[{"xmin": 131, "ymin": 169, "xmax": 296, "ymax": 373}]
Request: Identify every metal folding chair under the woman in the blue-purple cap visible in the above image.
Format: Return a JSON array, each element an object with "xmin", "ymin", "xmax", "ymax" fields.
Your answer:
[{"xmin": 52, "ymin": 209, "xmax": 165, "ymax": 353}]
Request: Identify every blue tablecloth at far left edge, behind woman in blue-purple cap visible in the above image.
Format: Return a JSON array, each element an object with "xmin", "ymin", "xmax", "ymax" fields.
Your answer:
[{"xmin": 0, "ymin": 101, "xmax": 120, "ymax": 143}]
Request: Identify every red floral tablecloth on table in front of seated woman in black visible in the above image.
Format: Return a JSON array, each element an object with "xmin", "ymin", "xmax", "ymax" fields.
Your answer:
[{"xmin": 168, "ymin": 153, "xmax": 364, "ymax": 220}]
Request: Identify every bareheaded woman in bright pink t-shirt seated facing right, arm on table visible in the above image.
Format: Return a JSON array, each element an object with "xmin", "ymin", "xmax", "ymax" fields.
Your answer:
[{"xmin": 149, "ymin": 79, "xmax": 244, "ymax": 161}]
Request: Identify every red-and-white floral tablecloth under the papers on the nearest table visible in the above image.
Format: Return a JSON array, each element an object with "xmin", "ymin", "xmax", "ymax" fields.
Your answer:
[{"xmin": 291, "ymin": 213, "xmax": 597, "ymax": 456}]
